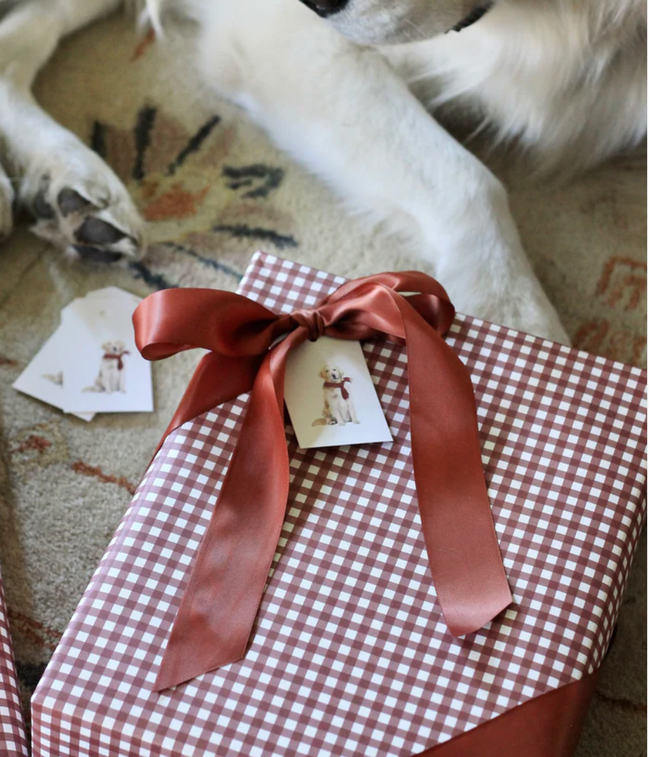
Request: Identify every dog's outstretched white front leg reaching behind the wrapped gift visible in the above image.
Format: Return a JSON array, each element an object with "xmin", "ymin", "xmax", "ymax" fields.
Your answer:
[{"xmin": 194, "ymin": 0, "xmax": 568, "ymax": 342}]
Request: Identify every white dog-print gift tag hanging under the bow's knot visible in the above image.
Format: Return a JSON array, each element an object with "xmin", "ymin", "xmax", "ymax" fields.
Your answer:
[{"xmin": 284, "ymin": 337, "xmax": 393, "ymax": 449}]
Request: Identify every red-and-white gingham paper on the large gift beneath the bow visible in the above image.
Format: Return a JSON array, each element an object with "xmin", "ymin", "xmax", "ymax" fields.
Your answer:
[{"xmin": 33, "ymin": 254, "xmax": 645, "ymax": 757}]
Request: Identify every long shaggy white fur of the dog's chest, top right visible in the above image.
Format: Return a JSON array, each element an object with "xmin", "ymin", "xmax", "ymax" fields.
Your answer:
[{"xmin": 384, "ymin": 0, "xmax": 647, "ymax": 172}]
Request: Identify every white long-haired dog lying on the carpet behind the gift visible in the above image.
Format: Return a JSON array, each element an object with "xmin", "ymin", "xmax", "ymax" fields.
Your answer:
[{"xmin": 0, "ymin": 0, "xmax": 647, "ymax": 341}]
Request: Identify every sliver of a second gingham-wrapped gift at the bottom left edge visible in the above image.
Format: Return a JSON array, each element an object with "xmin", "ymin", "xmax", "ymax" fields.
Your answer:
[{"xmin": 0, "ymin": 577, "xmax": 29, "ymax": 757}]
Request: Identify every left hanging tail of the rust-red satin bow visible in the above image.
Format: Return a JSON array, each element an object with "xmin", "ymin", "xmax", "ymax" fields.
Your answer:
[{"xmin": 154, "ymin": 333, "xmax": 304, "ymax": 691}]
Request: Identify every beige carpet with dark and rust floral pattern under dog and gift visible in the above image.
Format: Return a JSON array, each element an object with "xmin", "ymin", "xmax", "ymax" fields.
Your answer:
[{"xmin": 0, "ymin": 10, "xmax": 646, "ymax": 757}]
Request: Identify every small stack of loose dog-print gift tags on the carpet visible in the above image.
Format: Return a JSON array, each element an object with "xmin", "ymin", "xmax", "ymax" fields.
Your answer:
[{"xmin": 13, "ymin": 287, "xmax": 153, "ymax": 421}]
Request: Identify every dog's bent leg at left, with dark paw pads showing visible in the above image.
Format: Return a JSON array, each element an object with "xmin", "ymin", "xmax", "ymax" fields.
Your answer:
[{"xmin": 0, "ymin": 0, "xmax": 142, "ymax": 262}]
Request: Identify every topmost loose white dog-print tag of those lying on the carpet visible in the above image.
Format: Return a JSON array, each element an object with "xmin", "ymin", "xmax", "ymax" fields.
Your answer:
[{"xmin": 61, "ymin": 287, "xmax": 153, "ymax": 413}]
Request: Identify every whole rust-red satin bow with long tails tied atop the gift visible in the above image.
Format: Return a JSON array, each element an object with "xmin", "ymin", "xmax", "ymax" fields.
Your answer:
[{"xmin": 133, "ymin": 272, "xmax": 512, "ymax": 690}]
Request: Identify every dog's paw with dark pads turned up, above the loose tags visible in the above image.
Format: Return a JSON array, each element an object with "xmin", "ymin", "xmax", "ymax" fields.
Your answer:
[{"xmin": 20, "ymin": 140, "xmax": 144, "ymax": 263}]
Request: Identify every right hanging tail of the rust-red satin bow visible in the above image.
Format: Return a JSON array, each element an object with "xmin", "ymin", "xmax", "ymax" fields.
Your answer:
[{"xmin": 399, "ymin": 300, "xmax": 512, "ymax": 636}]
